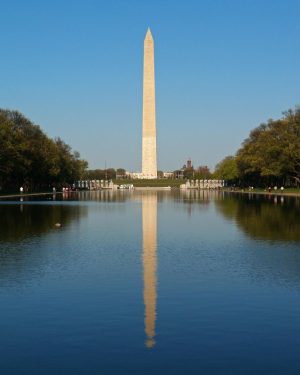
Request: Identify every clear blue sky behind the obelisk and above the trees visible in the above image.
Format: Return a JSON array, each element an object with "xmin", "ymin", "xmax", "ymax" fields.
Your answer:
[{"xmin": 0, "ymin": 0, "xmax": 300, "ymax": 171}]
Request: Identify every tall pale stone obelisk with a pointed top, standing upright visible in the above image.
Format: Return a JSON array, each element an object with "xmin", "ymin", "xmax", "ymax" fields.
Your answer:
[{"xmin": 142, "ymin": 29, "xmax": 157, "ymax": 179}]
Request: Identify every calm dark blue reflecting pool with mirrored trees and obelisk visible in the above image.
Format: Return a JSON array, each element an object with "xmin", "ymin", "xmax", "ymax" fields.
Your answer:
[{"xmin": 0, "ymin": 192, "xmax": 300, "ymax": 375}]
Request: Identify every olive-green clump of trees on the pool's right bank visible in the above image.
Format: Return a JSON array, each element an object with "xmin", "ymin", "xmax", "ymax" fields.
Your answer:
[{"xmin": 214, "ymin": 107, "xmax": 300, "ymax": 187}]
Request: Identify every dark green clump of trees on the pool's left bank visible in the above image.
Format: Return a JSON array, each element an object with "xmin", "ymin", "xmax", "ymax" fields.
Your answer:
[{"xmin": 0, "ymin": 109, "xmax": 88, "ymax": 191}]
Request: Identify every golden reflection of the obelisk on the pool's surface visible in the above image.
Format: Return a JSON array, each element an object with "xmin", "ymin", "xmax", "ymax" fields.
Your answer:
[{"xmin": 142, "ymin": 192, "xmax": 157, "ymax": 348}]
